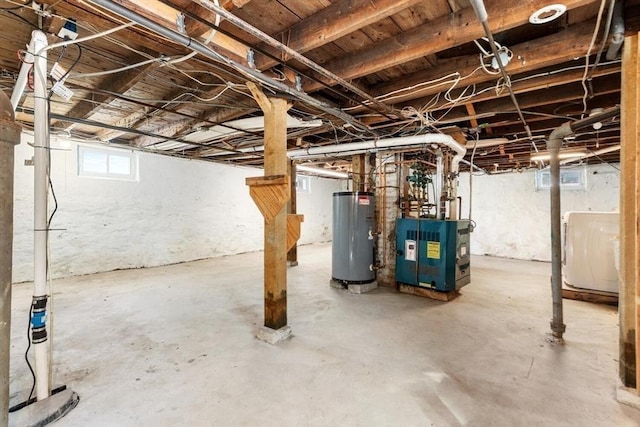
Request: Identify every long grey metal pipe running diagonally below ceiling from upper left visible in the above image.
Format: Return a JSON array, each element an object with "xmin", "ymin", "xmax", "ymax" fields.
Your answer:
[{"xmin": 91, "ymin": 0, "xmax": 376, "ymax": 134}]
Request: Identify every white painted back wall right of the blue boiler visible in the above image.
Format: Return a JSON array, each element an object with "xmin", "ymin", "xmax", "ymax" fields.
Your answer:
[{"xmin": 458, "ymin": 164, "xmax": 620, "ymax": 261}]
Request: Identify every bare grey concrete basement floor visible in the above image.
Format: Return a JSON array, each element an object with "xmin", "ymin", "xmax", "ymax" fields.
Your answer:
[{"xmin": 10, "ymin": 244, "xmax": 640, "ymax": 427}]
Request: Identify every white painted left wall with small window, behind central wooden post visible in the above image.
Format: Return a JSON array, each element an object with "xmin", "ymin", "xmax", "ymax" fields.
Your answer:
[{"xmin": 13, "ymin": 135, "xmax": 343, "ymax": 282}]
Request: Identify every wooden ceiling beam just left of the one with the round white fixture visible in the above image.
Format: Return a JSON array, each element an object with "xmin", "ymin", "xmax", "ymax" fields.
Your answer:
[{"xmin": 256, "ymin": 0, "xmax": 421, "ymax": 70}]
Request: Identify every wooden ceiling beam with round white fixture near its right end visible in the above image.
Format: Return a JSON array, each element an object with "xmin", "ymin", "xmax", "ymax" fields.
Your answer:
[{"xmin": 303, "ymin": 0, "xmax": 596, "ymax": 92}]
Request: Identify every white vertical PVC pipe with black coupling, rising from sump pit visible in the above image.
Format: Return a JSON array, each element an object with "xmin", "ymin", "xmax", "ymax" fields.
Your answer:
[{"xmin": 32, "ymin": 30, "xmax": 50, "ymax": 400}]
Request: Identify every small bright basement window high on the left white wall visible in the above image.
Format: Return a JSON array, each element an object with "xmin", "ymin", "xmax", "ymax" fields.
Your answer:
[{"xmin": 78, "ymin": 145, "xmax": 138, "ymax": 181}]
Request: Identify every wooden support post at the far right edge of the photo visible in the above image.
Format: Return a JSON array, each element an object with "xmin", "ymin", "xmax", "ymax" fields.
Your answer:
[{"xmin": 619, "ymin": 34, "xmax": 640, "ymax": 391}]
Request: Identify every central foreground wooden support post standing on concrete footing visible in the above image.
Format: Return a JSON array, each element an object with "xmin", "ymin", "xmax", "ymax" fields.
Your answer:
[{"xmin": 247, "ymin": 82, "xmax": 290, "ymax": 329}]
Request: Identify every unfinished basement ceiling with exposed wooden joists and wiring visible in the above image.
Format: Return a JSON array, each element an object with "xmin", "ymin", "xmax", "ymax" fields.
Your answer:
[{"xmin": 0, "ymin": 0, "xmax": 640, "ymax": 172}]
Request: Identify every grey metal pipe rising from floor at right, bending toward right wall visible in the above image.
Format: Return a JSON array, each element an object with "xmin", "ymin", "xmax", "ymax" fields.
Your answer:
[{"xmin": 547, "ymin": 106, "xmax": 620, "ymax": 343}]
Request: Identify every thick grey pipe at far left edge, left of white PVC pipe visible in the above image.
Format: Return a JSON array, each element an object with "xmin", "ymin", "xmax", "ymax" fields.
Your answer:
[{"xmin": 0, "ymin": 90, "xmax": 21, "ymax": 426}]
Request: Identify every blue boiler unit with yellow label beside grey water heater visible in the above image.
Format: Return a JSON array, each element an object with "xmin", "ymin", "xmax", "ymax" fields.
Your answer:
[{"xmin": 396, "ymin": 218, "xmax": 471, "ymax": 292}]
